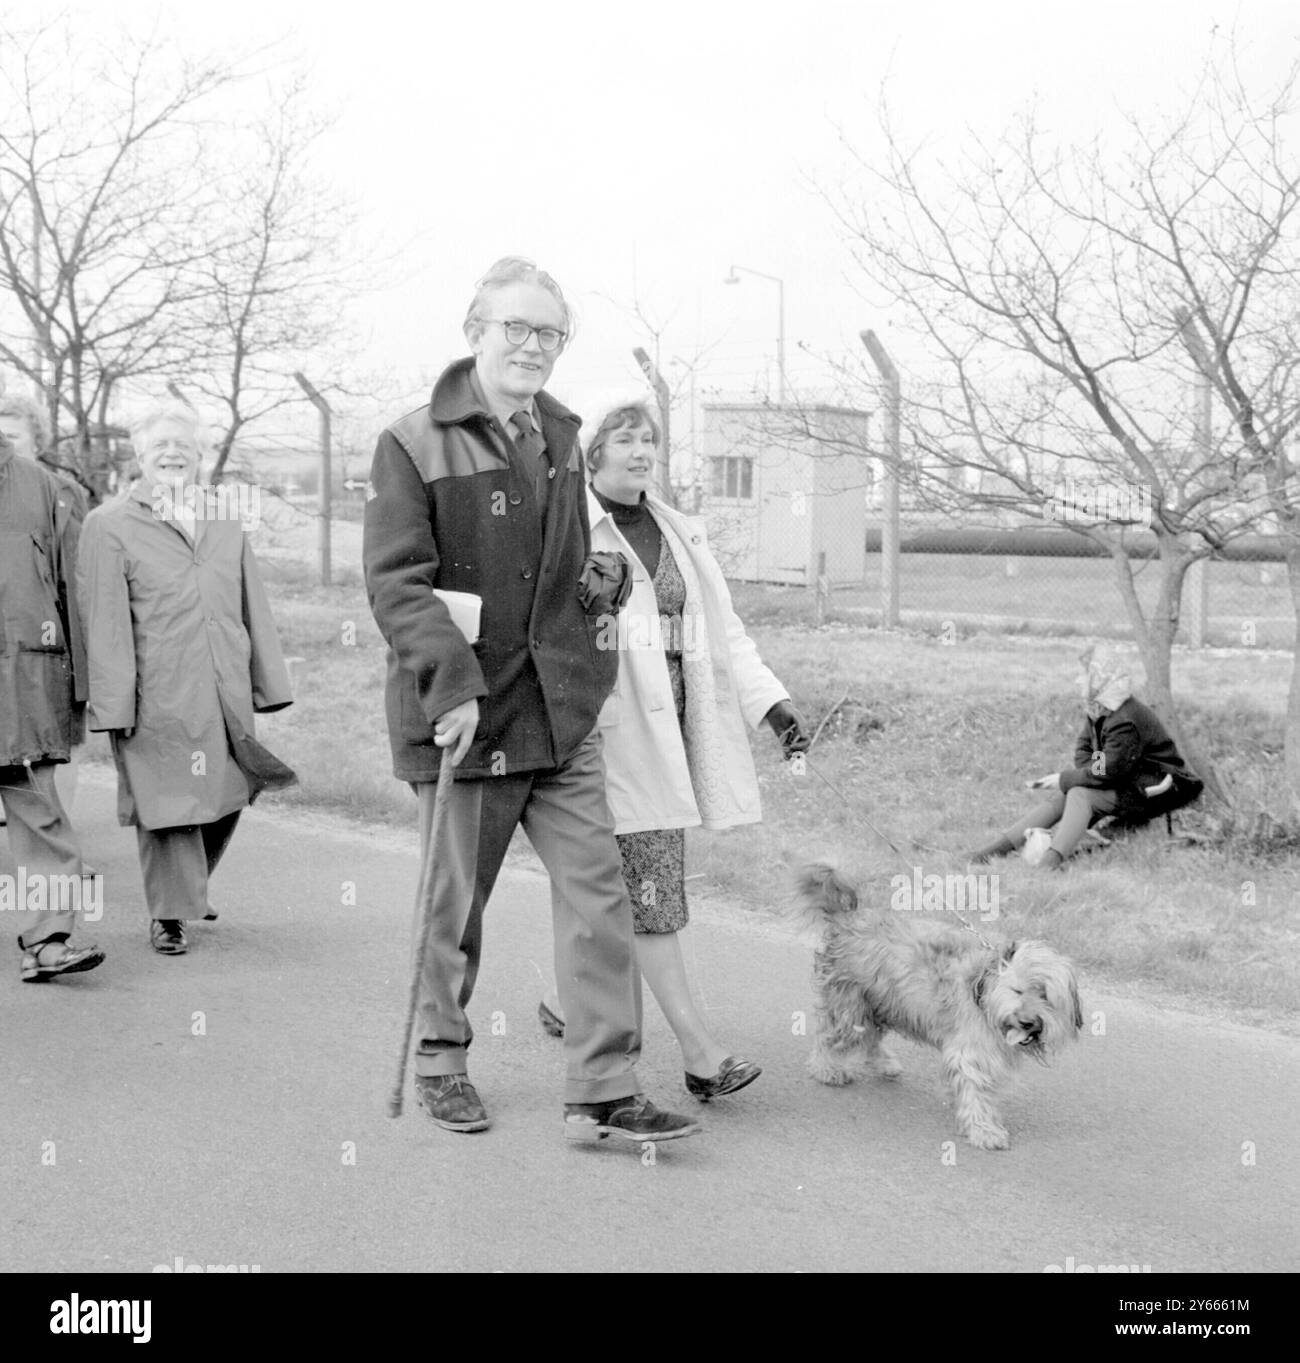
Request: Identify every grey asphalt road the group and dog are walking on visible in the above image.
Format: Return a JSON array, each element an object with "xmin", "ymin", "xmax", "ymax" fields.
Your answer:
[{"xmin": 0, "ymin": 774, "xmax": 1300, "ymax": 1273}]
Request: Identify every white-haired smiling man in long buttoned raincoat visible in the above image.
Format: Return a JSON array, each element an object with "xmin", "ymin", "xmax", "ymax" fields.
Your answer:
[{"xmin": 78, "ymin": 403, "xmax": 294, "ymax": 955}]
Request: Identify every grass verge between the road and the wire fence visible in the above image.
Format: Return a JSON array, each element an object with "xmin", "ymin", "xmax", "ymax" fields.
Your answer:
[{"xmin": 78, "ymin": 556, "xmax": 1300, "ymax": 1022}]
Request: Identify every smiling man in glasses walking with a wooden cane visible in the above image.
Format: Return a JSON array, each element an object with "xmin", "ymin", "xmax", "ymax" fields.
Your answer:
[{"xmin": 364, "ymin": 256, "xmax": 700, "ymax": 1142}]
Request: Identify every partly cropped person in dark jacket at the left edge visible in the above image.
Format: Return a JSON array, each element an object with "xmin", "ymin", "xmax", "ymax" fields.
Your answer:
[{"xmin": 0, "ymin": 414, "xmax": 104, "ymax": 983}]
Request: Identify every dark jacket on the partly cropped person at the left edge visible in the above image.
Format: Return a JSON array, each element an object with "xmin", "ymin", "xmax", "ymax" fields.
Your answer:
[{"xmin": 0, "ymin": 440, "xmax": 86, "ymax": 766}]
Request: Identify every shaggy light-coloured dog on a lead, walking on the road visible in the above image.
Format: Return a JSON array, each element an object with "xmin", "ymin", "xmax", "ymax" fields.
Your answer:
[{"xmin": 797, "ymin": 864, "xmax": 1083, "ymax": 1150}]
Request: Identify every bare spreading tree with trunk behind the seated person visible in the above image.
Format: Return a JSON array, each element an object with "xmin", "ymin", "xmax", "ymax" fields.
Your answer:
[{"xmin": 827, "ymin": 50, "xmax": 1300, "ymax": 796}]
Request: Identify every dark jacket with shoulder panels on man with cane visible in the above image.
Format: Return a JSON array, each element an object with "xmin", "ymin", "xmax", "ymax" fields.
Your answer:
[{"xmin": 362, "ymin": 360, "xmax": 619, "ymax": 781}]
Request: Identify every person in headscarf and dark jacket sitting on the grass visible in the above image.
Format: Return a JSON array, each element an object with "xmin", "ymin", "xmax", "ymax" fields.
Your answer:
[{"xmin": 968, "ymin": 645, "xmax": 1203, "ymax": 870}]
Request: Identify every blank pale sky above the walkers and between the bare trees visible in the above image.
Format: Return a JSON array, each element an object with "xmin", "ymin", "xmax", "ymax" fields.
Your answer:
[{"xmin": 7, "ymin": 0, "xmax": 1300, "ymax": 441}]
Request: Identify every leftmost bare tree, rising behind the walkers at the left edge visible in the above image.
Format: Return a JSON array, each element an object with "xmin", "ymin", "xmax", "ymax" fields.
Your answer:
[{"xmin": 0, "ymin": 19, "xmax": 236, "ymax": 488}]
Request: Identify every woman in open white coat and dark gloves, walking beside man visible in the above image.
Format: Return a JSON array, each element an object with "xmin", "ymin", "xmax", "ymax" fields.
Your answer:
[{"xmin": 540, "ymin": 403, "xmax": 808, "ymax": 1100}]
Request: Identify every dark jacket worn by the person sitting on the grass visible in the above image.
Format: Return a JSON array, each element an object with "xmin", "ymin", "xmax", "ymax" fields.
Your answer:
[{"xmin": 1060, "ymin": 696, "xmax": 1203, "ymax": 819}]
